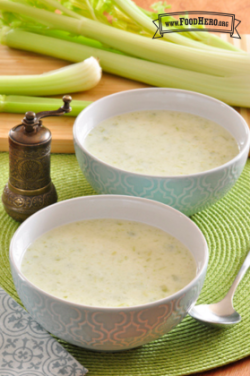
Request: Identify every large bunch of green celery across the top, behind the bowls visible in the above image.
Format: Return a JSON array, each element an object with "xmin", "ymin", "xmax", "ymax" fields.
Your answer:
[{"xmin": 0, "ymin": 0, "xmax": 250, "ymax": 107}]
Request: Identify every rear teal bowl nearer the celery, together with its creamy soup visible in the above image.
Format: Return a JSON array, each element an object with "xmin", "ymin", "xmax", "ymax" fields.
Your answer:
[{"xmin": 73, "ymin": 88, "xmax": 250, "ymax": 215}]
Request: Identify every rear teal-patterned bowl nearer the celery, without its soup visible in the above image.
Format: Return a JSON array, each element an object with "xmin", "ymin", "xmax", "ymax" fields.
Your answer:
[{"xmin": 73, "ymin": 88, "xmax": 250, "ymax": 215}]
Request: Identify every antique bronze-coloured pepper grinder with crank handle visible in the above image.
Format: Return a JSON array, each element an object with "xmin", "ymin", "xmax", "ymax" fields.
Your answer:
[{"xmin": 2, "ymin": 95, "xmax": 72, "ymax": 222}]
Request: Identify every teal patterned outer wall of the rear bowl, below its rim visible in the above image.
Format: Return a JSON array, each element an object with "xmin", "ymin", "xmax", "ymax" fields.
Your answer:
[{"xmin": 75, "ymin": 144, "xmax": 248, "ymax": 216}]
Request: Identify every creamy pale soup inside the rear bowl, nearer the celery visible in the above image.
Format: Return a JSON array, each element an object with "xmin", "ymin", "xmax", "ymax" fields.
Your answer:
[{"xmin": 84, "ymin": 110, "xmax": 239, "ymax": 176}]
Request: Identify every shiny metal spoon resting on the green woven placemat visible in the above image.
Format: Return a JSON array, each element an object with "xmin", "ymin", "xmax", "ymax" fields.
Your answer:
[{"xmin": 189, "ymin": 251, "xmax": 250, "ymax": 326}]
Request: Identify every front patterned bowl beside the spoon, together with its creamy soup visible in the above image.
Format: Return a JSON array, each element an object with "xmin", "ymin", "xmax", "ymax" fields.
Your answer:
[{"xmin": 10, "ymin": 195, "xmax": 208, "ymax": 351}]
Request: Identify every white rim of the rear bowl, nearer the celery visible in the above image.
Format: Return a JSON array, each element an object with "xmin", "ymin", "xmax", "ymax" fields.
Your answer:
[{"xmin": 73, "ymin": 87, "xmax": 250, "ymax": 180}]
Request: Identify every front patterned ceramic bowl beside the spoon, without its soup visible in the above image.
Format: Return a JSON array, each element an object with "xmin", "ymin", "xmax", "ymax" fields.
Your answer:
[{"xmin": 10, "ymin": 195, "xmax": 208, "ymax": 351}]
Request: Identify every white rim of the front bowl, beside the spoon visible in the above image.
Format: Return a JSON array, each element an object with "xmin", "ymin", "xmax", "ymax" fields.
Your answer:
[{"xmin": 9, "ymin": 195, "xmax": 209, "ymax": 312}]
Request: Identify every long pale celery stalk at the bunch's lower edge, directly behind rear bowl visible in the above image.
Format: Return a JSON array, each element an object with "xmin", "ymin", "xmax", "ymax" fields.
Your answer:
[{"xmin": 1, "ymin": 29, "xmax": 250, "ymax": 107}]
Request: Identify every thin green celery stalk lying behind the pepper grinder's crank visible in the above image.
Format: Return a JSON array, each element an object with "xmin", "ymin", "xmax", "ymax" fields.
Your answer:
[{"xmin": 0, "ymin": 95, "xmax": 92, "ymax": 116}]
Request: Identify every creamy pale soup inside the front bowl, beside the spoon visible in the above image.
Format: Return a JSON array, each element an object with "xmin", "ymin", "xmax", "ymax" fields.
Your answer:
[{"xmin": 22, "ymin": 219, "xmax": 196, "ymax": 307}]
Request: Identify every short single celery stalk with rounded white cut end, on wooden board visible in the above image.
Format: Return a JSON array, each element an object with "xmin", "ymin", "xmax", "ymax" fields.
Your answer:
[{"xmin": 0, "ymin": 57, "xmax": 101, "ymax": 96}]
